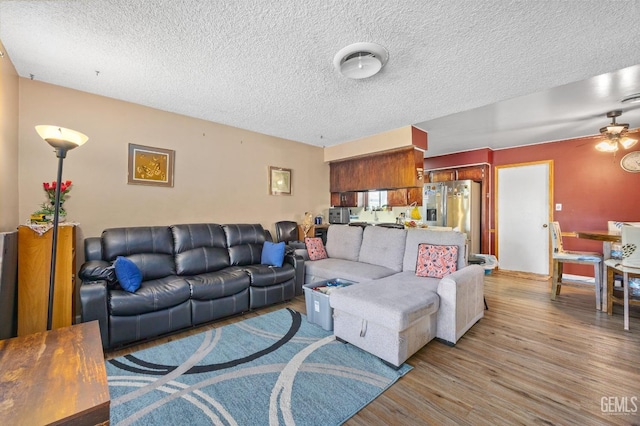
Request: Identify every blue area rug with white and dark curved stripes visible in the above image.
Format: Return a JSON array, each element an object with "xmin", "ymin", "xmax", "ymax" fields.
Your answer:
[{"xmin": 107, "ymin": 309, "xmax": 411, "ymax": 426}]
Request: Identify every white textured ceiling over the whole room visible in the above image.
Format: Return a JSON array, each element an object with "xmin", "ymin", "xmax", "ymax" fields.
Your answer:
[{"xmin": 0, "ymin": 0, "xmax": 640, "ymax": 156}]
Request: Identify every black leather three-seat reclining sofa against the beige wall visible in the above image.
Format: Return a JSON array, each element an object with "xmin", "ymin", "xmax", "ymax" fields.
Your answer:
[{"xmin": 79, "ymin": 224, "xmax": 304, "ymax": 349}]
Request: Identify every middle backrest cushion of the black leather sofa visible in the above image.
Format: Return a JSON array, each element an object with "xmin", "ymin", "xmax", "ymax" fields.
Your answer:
[{"xmin": 171, "ymin": 223, "xmax": 230, "ymax": 275}]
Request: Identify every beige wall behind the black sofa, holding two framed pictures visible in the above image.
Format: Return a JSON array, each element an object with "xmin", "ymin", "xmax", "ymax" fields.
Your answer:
[{"xmin": 19, "ymin": 78, "xmax": 330, "ymax": 254}]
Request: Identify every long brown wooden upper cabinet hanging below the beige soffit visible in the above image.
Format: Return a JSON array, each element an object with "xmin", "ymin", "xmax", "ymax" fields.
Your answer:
[{"xmin": 329, "ymin": 148, "xmax": 424, "ymax": 192}]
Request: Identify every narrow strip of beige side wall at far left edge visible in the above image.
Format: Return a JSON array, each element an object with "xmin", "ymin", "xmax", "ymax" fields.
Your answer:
[{"xmin": 0, "ymin": 42, "xmax": 20, "ymax": 232}]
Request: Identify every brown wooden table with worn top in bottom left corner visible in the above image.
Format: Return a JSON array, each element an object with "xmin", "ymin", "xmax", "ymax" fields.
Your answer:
[{"xmin": 0, "ymin": 321, "xmax": 110, "ymax": 425}]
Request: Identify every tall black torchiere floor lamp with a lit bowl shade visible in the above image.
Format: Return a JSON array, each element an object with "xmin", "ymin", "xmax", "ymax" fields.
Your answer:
[{"xmin": 36, "ymin": 125, "xmax": 89, "ymax": 330}]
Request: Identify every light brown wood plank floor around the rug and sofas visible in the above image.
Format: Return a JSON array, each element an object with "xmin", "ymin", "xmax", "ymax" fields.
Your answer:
[{"xmin": 106, "ymin": 271, "xmax": 640, "ymax": 425}]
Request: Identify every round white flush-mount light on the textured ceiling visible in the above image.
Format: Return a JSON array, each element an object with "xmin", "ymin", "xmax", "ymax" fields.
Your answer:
[{"xmin": 333, "ymin": 42, "xmax": 389, "ymax": 80}]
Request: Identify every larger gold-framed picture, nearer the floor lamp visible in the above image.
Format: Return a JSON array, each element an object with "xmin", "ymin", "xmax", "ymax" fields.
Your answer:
[{"xmin": 127, "ymin": 143, "xmax": 175, "ymax": 187}]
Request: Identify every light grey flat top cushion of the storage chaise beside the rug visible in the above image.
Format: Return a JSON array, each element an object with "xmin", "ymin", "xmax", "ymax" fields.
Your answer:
[{"xmin": 329, "ymin": 277, "xmax": 440, "ymax": 331}]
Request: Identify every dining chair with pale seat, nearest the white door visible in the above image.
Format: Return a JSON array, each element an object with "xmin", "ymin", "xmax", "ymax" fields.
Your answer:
[{"xmin": 549, "ymin": 222, "xmax": 603, "ymax": 310}]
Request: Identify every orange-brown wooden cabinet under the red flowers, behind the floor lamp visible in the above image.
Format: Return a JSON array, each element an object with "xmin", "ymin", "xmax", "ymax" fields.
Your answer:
[{"xmin": 18, "ymin": 224, "xmax": 76, "ymax": 336}]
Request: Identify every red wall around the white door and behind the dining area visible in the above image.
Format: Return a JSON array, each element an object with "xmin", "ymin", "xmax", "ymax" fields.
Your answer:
[{"xmin": 425, "ymin": 130, "xmax": 640, "ymax": 276}]
